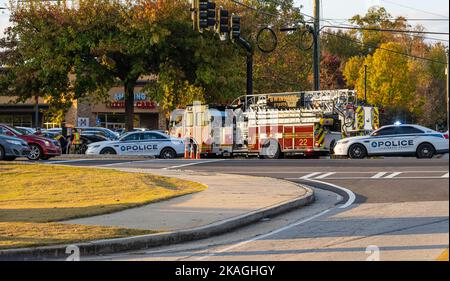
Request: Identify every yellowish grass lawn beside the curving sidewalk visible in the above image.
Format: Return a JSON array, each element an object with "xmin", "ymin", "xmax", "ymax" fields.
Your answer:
[{"xmin": 0, "ymin": 162, "xmax": 206, "ymax": 249}]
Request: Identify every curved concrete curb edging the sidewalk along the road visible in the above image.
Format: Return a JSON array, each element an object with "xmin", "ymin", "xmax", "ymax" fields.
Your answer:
[{"xmin": 0, "ymin": 184, "xmax": 315, "ymax": 260}]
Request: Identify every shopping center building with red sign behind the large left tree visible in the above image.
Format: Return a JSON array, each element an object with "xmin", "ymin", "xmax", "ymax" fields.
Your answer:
[{"xmin": 0, "ymin": 83, "xmax": 167, "ymax": 130}]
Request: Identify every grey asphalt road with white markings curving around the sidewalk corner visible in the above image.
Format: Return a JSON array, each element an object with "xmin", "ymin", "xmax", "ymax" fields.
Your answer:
[{"xmin": 40, "ymin": 158, "xmax": 449, "ymax": 260}]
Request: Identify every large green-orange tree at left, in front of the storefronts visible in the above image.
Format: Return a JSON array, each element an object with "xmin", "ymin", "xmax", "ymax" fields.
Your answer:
[{"xmin": 0, "ymin": 0, "xmax": 246, "ymax": 130}]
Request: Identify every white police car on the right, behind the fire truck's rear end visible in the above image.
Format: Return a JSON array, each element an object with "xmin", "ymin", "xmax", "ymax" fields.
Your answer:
[{"xmin": 334, "ymin": 125, "xmax": 449, "ymax": 159}]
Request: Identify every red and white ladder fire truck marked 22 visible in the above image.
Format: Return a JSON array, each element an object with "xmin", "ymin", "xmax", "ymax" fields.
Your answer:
[{"xmin": 170, "ymin": 90, "xmax": 379, "ymax": 159}]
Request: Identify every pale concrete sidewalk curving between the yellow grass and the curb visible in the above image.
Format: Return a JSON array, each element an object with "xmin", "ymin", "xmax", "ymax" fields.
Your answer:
[{"xmin": 66, "ymin": 168, "xmax": 310, "ymax": 231}]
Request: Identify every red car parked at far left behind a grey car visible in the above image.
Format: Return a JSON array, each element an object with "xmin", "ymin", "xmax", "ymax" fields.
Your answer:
[{"xmin": 0, "ymin": 124, "xmax": 61, "ymax": 160}]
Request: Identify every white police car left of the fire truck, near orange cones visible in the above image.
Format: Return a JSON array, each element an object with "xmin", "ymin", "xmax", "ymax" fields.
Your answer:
[{"xmin": 86, "ymin": 131, "xmax": 184, "ymax": 159}]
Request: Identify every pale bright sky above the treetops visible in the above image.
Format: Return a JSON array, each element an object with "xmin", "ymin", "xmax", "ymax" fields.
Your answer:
[{"xmin": 0, "ymin": 0, "xmax": 449, "ymax": 45}]
